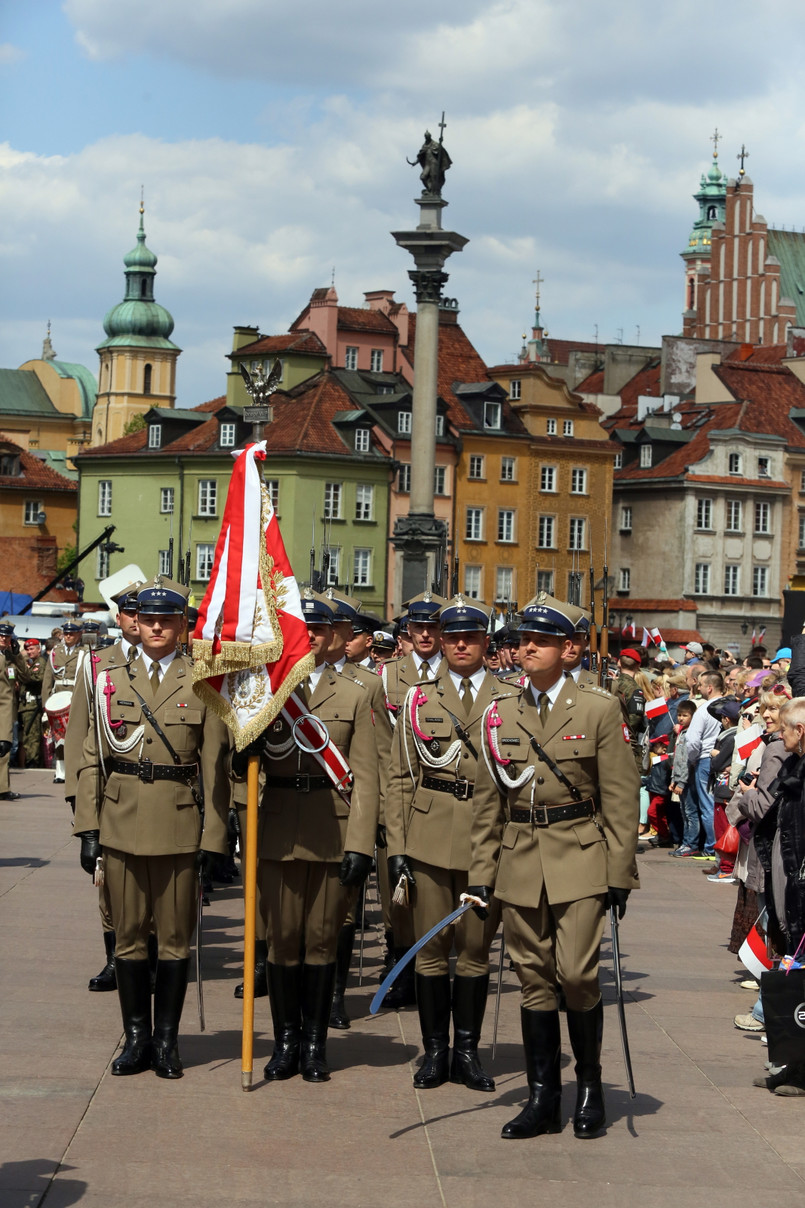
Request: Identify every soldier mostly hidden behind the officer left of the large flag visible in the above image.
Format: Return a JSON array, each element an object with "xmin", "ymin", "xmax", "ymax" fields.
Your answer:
[{"xmin": 64, "ymin": 580, "xmax": 144, "ymax": 993}]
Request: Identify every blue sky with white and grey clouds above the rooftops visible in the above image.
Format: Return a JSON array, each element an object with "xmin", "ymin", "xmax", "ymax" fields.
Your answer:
[{"xmin": 0, "ymin": 0, "xmax": 805, "ymax": 406}]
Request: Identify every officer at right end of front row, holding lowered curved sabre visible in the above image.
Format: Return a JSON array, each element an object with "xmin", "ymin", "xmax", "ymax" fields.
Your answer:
[{"xmin": 469, "ymin": 597, "xmax": 639, "ymax": 1138}]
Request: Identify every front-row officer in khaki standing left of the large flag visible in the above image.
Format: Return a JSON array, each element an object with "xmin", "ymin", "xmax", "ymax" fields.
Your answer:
[{"xmin": 75, "ymin": 575, "xmax": 230, "ymax": 1078}]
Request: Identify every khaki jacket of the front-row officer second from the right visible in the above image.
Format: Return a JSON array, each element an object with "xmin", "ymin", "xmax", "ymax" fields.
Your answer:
[{"xmin": 386, "ymin": 662, "xmax": 514, "ymax": 872}]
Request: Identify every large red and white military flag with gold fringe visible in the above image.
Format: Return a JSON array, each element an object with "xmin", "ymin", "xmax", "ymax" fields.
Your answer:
[{"xmin": 193, "ymin": 441, "xmax": 314, "ymax": 750}]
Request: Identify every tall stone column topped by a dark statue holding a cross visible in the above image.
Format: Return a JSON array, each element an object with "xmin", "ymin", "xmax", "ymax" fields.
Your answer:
[{"xmin": 392, "ymin": 125, "xmax": 469, "ymax": 608}]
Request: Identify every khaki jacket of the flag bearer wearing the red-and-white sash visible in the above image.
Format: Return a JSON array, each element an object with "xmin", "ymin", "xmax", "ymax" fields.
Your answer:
[{"xmin": 257, "ymin": 667, "xmax": 380, "ymax": 863}]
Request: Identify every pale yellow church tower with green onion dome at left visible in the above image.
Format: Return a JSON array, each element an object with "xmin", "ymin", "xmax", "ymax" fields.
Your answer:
[{"xmin": 92, "ymin": 202, "xmax": 181, "ymax": 446}]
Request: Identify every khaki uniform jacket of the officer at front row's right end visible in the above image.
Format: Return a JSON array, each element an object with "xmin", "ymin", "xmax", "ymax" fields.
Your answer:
[{"xmin": 469, "ymin": 680, "xmax": 639, "ymax": 908}]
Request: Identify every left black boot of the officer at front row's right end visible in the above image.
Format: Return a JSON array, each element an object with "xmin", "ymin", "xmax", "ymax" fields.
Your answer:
[{"xmin": 500, "ymin": 1006, "xmax": 562, "ymax": 1140}]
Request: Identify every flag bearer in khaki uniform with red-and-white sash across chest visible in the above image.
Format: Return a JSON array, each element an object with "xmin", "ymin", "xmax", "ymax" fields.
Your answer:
[{"xmin": 257, "ymin": 588, "xmax": 380, "ymax": 1082}]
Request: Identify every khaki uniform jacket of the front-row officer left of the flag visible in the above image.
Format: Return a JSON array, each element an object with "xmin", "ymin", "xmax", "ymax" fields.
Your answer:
[{"xmin": 75, "ymin": 655, "xmax": 230, "ymax": 855}]
